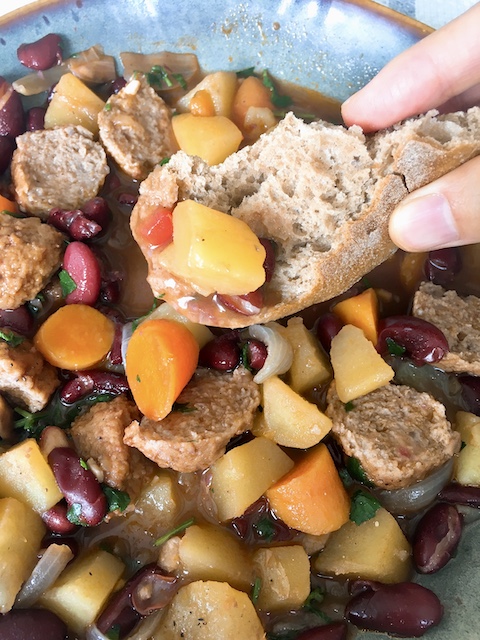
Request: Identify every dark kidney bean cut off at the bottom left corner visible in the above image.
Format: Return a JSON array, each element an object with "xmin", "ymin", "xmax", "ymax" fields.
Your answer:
[{"xmin": 0, "ymin": 609, "xmax": 68, "ymax": 640}]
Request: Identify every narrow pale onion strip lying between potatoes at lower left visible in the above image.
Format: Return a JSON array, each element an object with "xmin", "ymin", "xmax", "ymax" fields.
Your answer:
[{"xmin": 15, "ymin": 544, "xmax": 73, "ymax": 609}]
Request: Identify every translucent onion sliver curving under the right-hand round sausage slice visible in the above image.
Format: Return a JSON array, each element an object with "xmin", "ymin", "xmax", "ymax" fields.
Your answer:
[{"xmin": 374, "ymin": 458, "xmax": 453, "ymax": 515}]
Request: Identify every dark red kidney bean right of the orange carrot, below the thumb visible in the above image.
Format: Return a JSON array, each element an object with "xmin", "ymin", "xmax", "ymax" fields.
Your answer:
[{"xmin": 377, "ymin": 316, "xmax": 449, "ymax": 366}]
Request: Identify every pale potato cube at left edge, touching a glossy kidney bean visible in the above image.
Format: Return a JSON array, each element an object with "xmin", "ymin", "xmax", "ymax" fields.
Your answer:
[{"xmin": 0, "ymin": 438, "xmax": 63, "ymax": 514}]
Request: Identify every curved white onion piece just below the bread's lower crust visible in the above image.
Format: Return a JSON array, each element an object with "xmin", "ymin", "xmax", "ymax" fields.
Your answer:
[{"xmin": 247, "ymin": 322, "xmax": 293, "ymax": 384}]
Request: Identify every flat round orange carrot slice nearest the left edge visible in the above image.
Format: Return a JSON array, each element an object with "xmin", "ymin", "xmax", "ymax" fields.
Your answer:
[{"xmin": 34, "ymin": 304, "xmax": 115, "ymax": 371}]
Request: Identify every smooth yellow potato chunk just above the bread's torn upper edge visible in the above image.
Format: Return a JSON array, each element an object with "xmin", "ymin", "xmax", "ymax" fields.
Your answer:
[{"xmin": 172, "ymin": 113, "xmax": 243, "ymax": 165}]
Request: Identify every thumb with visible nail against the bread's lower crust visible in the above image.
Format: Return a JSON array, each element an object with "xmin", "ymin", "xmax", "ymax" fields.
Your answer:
[{"xmin": 389, "ymin": 156, "xmax": 480, "ymax": 251}]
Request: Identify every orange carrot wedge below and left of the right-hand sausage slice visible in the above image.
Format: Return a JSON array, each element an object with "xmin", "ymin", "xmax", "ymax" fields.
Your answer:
[{"xmin": 266, "ymin": 444, "xmax": 350, "ymax": 536}]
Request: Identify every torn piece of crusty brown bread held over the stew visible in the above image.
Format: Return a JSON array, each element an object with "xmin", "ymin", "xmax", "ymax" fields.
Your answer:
[{"xmin": 131, "ymin": 108, "xmax": 480, "ymax": 327}]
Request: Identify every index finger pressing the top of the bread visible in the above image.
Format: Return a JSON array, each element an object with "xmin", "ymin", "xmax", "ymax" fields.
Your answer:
[{"xmin": 342, "ymin": 3, "xmax": 480, "ymax": 131}]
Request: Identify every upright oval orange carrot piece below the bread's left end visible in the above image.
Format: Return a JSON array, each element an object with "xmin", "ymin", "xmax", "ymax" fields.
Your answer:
[{"xmin": 126, "ymin": 319, "xmax": 199, "ymax": 420}]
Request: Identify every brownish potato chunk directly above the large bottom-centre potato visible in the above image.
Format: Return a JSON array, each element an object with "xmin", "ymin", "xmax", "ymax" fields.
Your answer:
[{"xmin": 178, "ymin": 524, "xmax": 252, "ymax": 591}]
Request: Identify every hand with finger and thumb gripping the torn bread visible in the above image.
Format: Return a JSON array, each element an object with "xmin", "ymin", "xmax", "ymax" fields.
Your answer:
[{"xmin": 342, "ymin": 3, "xmax": 480, "ymax": 251}]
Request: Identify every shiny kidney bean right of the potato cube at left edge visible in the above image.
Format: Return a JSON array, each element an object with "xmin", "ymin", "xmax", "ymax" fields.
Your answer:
[{"xmin": 48, "ymin": 447, "xmax": 107, "ymax": 527}]
